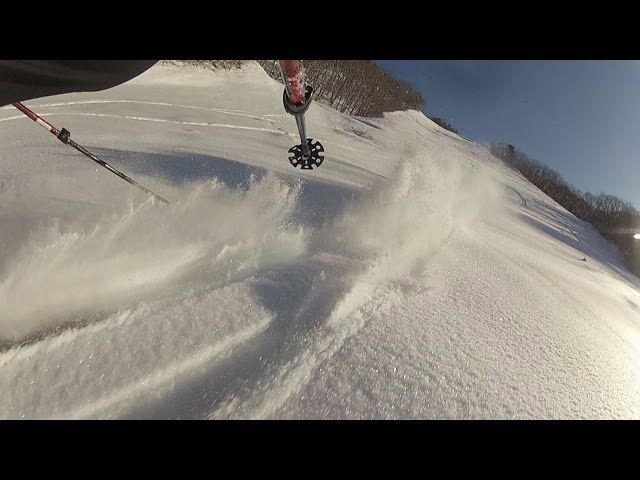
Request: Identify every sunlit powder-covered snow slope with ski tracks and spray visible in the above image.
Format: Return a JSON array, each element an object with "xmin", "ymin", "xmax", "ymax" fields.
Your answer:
[{"xmin": 0, "ymin": 63, "xmax": 640, "ymax": 419}]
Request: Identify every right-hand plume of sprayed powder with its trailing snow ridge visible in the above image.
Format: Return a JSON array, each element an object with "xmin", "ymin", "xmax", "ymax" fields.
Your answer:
[{"xmin": 209, "ymin": 144, "xmax": 496, "ymax": 418}]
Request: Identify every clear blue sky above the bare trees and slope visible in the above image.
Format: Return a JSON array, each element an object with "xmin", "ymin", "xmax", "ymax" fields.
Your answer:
[{"xmin": 376, "ymin": 60, "xmax": 640, "ymax": 209}]
